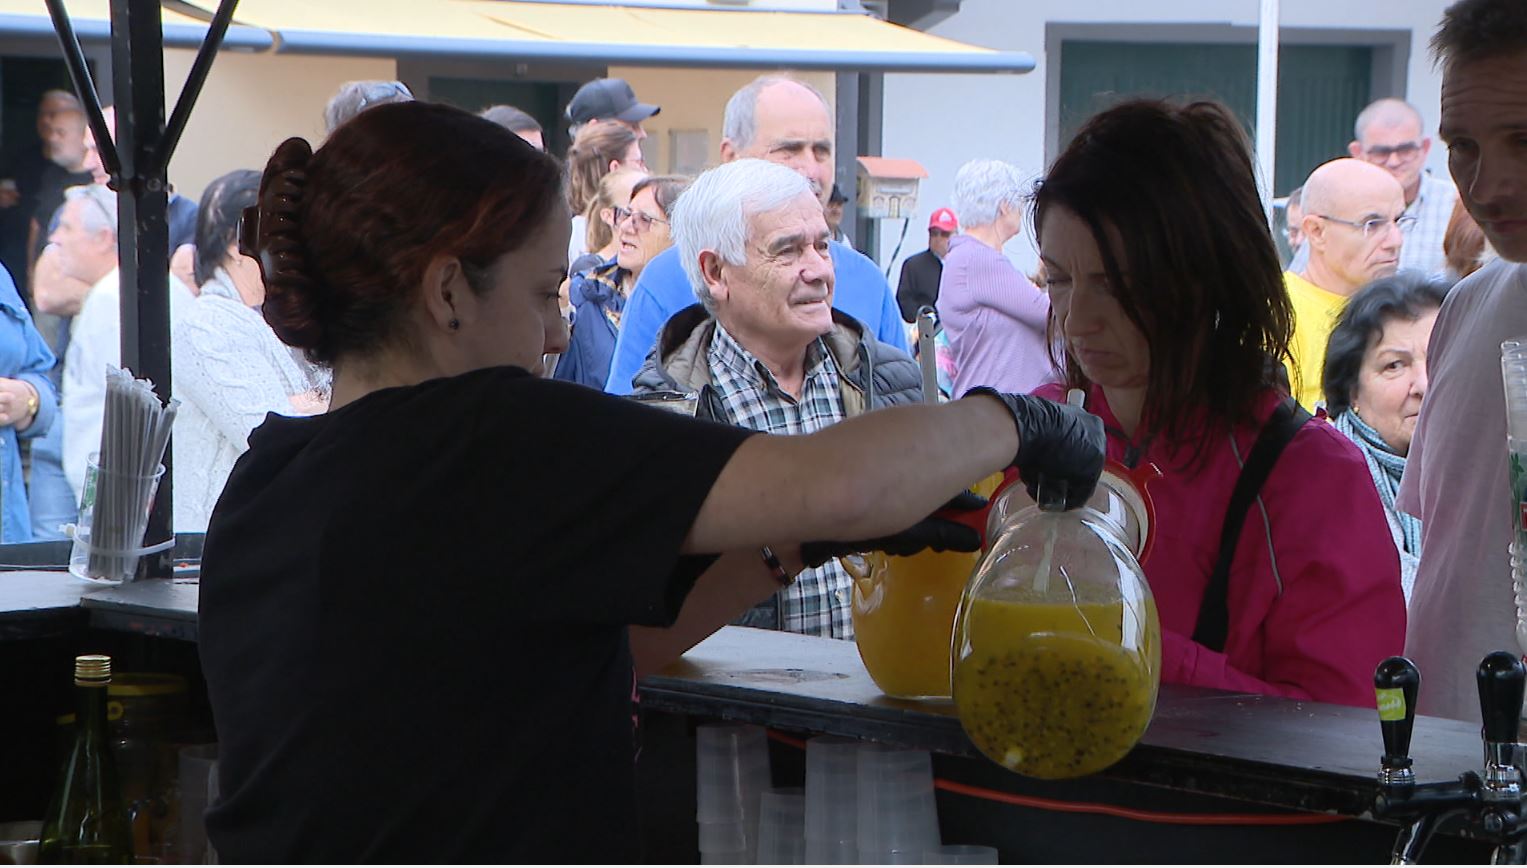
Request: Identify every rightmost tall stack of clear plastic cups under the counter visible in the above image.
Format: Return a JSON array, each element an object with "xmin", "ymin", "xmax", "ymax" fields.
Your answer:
[{"xmin": 858, "ymin": 744, "xmax": 941, "ymax": 865}]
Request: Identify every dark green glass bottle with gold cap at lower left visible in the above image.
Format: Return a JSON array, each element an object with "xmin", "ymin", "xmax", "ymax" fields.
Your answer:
[{"xmin": 37, "ymin": 654, "xmax": 133, "ymax": 865}]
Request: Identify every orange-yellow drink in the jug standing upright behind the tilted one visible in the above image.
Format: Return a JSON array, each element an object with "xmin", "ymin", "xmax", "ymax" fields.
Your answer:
[{"xmin": 854, "ymin": 552, "xmax": 980, "ymax": 698}]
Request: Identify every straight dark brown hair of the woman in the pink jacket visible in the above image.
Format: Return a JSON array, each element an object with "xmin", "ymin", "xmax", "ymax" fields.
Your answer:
[{"xmin": 1034, "ymin": 99, "xmax": 1293, "ymax": 467}]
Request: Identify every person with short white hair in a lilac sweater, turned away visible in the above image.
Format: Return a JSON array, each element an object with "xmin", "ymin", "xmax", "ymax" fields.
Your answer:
[{"xmin": 938, "ymin": 160, "xmax": 1055, "ymax": 397}]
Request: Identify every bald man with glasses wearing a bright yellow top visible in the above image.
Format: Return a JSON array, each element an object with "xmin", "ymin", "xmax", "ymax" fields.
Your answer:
[{"xmin": 1283, "ymin": 157, "xmax": 1398, "ymax": 410}]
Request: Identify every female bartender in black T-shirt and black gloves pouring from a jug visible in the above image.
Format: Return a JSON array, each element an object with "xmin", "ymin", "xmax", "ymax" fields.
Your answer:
[{"xmin": 200, "ymin": 102, "xmax": 1102, "ymax": 862}]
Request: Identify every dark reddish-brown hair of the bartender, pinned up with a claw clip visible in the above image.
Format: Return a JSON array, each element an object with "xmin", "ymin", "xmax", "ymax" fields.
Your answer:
[{"xmin": 241, "ymin": 102, "xmax": 562, "ymax": 362}]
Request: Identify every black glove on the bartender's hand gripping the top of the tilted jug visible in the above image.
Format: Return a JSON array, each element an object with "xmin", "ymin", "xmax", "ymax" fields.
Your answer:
[{"xmin": 965, "ymin": 387, "xmax": 1107, "ymax": 509}]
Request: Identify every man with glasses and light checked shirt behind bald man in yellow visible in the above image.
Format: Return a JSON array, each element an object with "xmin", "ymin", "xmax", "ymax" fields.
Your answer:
[{"xmin": 1347, "ymin": 99, "xmax": 1458, "ymax": 274}]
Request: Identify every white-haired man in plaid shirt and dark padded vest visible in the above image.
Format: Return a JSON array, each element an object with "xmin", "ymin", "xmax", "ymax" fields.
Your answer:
[{"xmin": 634, "ymin": 159, "xmax": 921, "ymax": 639}]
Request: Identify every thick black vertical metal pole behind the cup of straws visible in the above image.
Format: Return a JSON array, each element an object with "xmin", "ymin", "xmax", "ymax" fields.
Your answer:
[{"xmin": 110, "ymin": 0, "xmax": 174, "ymax": 579}]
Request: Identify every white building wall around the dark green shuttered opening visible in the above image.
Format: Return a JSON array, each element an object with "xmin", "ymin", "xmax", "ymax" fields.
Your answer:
[{"xmin": 880, "ymin": 0, "xmax": 1448, "ymax": 277}]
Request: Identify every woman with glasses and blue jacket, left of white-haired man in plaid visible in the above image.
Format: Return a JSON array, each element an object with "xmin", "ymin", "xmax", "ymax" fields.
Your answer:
[{"xmin": 556, "ymin": 174, "xmax": 689, "ymax": 390}]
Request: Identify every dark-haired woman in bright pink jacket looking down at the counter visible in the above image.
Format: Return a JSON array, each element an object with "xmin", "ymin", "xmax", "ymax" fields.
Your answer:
[{"xmin": 1034, "ymin": 101, "xmax": 1405, "ymax": 706}]
